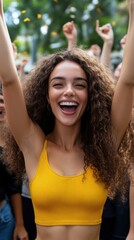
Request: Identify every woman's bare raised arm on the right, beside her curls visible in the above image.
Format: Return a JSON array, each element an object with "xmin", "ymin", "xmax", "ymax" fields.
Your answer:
[{"xmin": 111, "ymin": 0, "xmax": 134, "ymax": 148}]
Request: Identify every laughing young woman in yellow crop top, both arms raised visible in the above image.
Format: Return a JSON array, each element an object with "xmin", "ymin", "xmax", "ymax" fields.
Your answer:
[{"xmin": 0, "ymin": 0, "xmax": 134, "ymax": 240}]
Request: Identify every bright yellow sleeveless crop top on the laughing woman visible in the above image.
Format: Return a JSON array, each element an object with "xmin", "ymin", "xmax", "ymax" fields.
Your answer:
[{"xmin": 30, "ymin": 141, "xmax": 107, "ymax": 226}]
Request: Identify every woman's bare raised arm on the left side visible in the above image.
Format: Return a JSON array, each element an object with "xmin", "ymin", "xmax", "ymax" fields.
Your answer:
[{"xmin": 0, "ymin": 0, "xmax": 31, "ymax": 147}]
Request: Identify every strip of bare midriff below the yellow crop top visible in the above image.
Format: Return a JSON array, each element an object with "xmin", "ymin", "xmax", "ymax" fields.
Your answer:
[{"xmin": 36, "ymin": 225, "xmax": 100, "ymax": 240}]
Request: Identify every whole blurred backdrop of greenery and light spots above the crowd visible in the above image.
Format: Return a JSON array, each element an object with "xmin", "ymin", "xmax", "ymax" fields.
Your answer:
[{"xmin": 3, "ymin": 0, "xmax": 128, "ymax": 69}]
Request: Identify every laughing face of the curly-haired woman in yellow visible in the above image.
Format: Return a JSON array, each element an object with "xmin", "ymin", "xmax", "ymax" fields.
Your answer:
[{"xmin": 48, "ymin": 61, "xmax": 88, "ymax": 126}]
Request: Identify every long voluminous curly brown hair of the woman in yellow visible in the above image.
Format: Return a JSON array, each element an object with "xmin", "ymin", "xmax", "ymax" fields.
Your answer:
[{"xmin": 2, "ymin": 49, "xmax": 133, "ymax": 196}]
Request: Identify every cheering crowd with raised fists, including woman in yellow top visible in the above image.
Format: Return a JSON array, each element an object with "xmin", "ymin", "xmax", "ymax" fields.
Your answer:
[{"xmin": 0, "ymin": 0, "xmax": 134, "ymax": 240}]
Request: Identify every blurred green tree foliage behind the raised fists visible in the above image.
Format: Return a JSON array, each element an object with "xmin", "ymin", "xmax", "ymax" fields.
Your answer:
[{"xmin": 4, "ymin": 0, "xmax": 127, "ymax": 56}]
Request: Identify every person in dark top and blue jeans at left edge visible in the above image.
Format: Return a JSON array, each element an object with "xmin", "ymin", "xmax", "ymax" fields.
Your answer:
[{"xmin": 0, "ymin": 83, "xmax": 28, "ymax": 240}]
